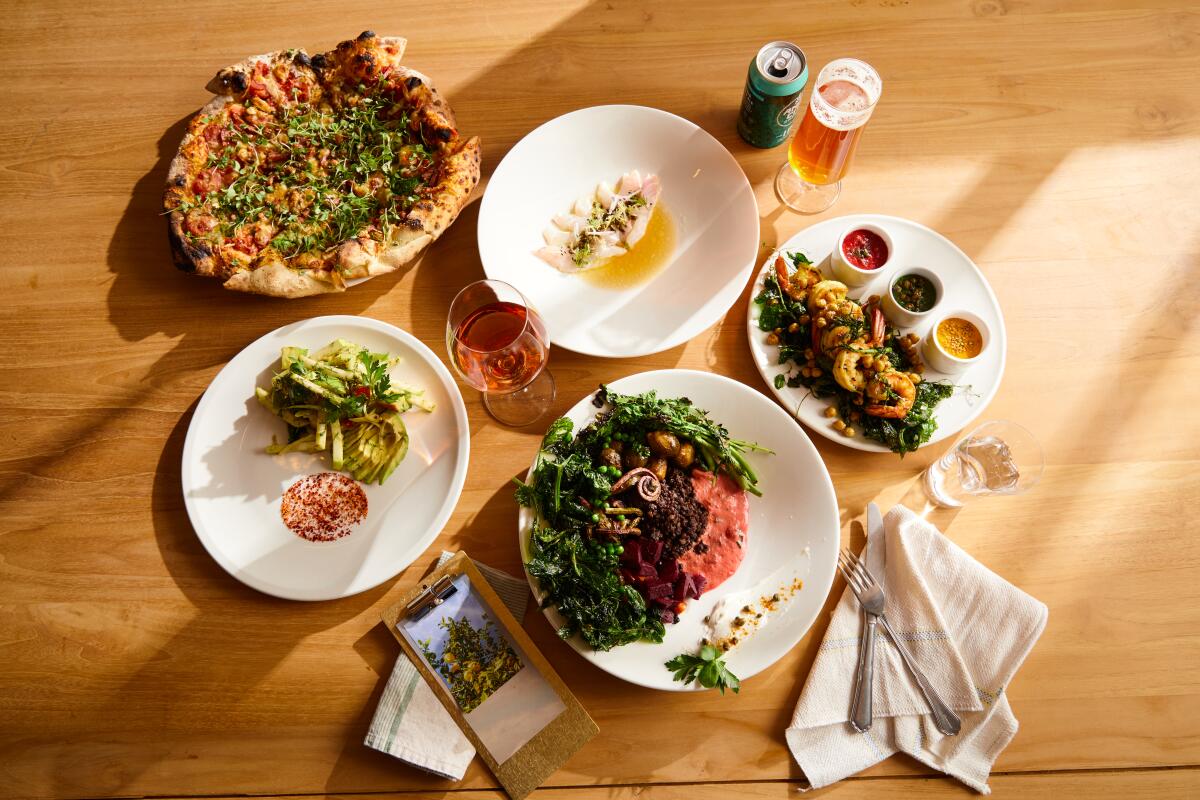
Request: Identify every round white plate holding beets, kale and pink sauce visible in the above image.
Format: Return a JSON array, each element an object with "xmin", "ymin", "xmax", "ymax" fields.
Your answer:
[{"xmin": 518, "ymin": 369, "xmax": 840, "ymax": 691}]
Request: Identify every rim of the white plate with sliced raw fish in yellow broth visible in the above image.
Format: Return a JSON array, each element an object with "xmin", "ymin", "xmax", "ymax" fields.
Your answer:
[{"xmin": 475, "ymin": 103, "xmax": 762, "ymax": 359}]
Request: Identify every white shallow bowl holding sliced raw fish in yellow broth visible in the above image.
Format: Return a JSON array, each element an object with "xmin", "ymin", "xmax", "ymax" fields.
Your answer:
[{"xmin": 479, "ymin": 106, "xmax": 758, "ymax": 357}]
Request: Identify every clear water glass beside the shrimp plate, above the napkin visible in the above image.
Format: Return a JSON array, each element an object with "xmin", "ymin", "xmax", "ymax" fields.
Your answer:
[{"xmin": 924, "ymin": 420, "xmax": 1045, "ymax": 509}]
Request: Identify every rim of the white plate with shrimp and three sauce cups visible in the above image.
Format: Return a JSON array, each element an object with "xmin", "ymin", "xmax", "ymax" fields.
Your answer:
[{"xmin": 746, "ymin": 212, "xmax": 1008, "ymax": 455}]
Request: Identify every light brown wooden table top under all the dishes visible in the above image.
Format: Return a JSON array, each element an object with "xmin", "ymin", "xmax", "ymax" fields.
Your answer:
[{"xmin": 0, "ymin": 0, "xmax": 1200, "ymax": 800}]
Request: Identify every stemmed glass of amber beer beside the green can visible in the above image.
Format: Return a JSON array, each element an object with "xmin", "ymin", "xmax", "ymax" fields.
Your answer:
[{"xmin": 775, "ymin": 59, "xmax": 883, "ymax": 213}]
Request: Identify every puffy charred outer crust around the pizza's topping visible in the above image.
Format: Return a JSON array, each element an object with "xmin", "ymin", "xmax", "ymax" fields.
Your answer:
[{"xmin": 163, "ymin": 32, "xmax": 481, "ymax": 297}]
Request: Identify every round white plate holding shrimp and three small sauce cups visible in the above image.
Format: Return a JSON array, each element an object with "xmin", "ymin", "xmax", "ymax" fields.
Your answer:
[{"xmin": 746, "ymin": 213, "xmax": 1008, "ymax": 452}]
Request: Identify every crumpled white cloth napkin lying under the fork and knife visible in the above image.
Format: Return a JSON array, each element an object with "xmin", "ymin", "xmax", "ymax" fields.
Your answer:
[{"xmin": 786, "ymin": 506, "xmax": 1048, "ymax": 794}]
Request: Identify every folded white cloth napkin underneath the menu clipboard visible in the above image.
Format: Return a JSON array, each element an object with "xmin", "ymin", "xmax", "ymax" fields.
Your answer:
[{"xmin": 364, "ymin": 552, "xmax": 529, "ymax": 781}]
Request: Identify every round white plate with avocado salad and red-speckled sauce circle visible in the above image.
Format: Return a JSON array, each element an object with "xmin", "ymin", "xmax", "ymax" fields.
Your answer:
[{"xmin": 182, "ymin": 315, "xmax": 470, "ymax": 600}]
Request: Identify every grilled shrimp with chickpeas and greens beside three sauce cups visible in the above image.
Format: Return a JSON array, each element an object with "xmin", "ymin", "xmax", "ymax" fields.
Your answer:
[{"xmin": 755, "ymin": 252, "xmax": 954, "ymax": 455}]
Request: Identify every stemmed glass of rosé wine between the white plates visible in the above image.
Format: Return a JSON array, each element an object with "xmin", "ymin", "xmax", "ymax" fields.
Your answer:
[{"xmin": 446, "ymin": 281, "xmax": 556, "ymax": 427}]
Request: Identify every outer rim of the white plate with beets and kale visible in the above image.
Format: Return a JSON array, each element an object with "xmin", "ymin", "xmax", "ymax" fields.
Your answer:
[{"xmin": 517, "ymin": 368, "xmax": 841, "ymax": 692}]
